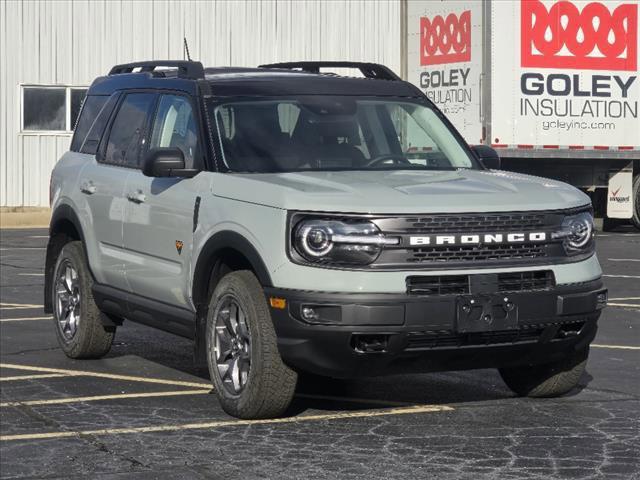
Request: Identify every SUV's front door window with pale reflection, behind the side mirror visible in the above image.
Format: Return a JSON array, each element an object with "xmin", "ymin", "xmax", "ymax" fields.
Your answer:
[{"xmin": 149, "ymin": 95, "xmax": 198, "ymax": 168}]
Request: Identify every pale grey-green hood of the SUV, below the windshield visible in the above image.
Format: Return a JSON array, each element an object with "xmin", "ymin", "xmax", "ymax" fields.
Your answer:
[{"xmin": 213, "ymin": 169, "xmax": 590, "ymax": 213}]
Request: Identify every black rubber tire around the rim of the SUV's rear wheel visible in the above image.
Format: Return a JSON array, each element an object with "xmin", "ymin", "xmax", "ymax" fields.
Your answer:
[{"xmin": 51, "ymin": 241, "xmax": 115, "ymax": 359}]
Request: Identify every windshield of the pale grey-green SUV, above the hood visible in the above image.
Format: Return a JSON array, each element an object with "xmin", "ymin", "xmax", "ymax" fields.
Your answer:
[{"xmin": 209, "ymin": 96, "xmax": 478, "ymax": 173}]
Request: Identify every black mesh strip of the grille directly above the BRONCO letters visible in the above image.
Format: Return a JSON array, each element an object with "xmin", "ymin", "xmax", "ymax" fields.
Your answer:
[{"xmin": 390, "ymin": 212, "xmax": 546, "ymax": 233}]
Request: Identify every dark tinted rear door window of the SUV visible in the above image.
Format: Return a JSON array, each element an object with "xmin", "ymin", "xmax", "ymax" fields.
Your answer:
[{"xmin": 104, "ymin": 93, "xmax": 156, "ymax": 167}]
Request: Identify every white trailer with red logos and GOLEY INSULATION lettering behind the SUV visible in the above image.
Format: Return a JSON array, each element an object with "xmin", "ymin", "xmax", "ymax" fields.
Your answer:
[{"xmin": 402, "ymin": 0, "xmax": 640, "ymax": 228}]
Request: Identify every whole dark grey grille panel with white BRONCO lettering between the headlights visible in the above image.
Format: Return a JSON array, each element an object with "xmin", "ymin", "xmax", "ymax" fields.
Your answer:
[{"xmin": 372, "ymin": 211, "xmax": 573, "ymax": 268}]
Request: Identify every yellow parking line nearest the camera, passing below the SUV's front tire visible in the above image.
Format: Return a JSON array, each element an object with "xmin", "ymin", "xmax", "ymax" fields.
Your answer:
[{"xmin": 0, "ymin": 405, "xmax": 453, "ymax": 442}]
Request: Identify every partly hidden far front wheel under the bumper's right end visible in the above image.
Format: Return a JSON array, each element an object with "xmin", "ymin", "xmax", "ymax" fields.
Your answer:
[{"xmin": 499, "ymin": 349, "xmax": 589, "ymax": 397}]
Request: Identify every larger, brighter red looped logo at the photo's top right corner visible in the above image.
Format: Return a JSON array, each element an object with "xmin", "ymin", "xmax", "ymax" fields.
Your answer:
[{"xmin": 520, "ymin": 0, "xmax": 638, "ymax": 71}]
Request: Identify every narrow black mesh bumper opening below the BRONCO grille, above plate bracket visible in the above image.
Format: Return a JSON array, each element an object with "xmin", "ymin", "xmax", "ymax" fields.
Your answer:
[{"xmin": 406, "ymin": 270, "xmax": 555, "ymax": 295}]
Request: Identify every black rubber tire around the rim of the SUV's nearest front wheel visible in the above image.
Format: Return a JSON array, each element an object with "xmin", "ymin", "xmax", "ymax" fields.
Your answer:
[{"xmin": 206, "ymin": 270, "xmax": 298, "ymax": 419}]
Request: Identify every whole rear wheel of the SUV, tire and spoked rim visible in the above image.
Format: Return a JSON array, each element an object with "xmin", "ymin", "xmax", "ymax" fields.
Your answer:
[{"xmin": 51, "ymin": 241, "xmax": 115, "ymax": 358}]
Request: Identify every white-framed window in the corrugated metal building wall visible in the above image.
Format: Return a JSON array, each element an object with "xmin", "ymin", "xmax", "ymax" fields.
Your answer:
[{"xmin": 22, "ymin": 86, "xmax": 87, "ymax": 132}]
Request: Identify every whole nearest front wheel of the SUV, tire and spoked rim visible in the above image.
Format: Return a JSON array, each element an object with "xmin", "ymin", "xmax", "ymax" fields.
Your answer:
[{"xmin": 206, "ymin": 270, "xmax": 297, "ymax": 419}]
